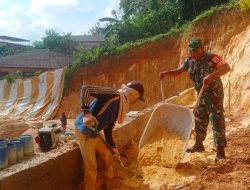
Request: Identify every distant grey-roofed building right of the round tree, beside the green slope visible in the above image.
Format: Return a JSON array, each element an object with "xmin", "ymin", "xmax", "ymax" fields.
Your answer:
[{"xmin": 71, "ymin": 35, "xmax": 105, "ymax": 50}]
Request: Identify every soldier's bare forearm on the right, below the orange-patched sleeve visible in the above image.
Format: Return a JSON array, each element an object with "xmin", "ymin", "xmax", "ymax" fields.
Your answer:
[{"xmin": 203, "ymin": 63, "xmax": 231, "ymax": 86}]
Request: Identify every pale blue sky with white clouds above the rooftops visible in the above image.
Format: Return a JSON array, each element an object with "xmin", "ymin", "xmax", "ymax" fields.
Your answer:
[{"xmin": 0, "ymin": 0, "xmax": 120, "ymax": 42}]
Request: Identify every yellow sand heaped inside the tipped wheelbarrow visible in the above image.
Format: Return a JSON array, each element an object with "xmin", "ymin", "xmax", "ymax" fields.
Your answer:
[{"xmin": 138, "ymin": 128, "xmax": 185, "ymax": 167}]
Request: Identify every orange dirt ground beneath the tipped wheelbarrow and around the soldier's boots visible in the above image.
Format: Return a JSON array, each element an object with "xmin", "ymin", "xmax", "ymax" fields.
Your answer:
[{"xmin": 101, "ymin": 114, "xmax": 250, "ymax": 190}]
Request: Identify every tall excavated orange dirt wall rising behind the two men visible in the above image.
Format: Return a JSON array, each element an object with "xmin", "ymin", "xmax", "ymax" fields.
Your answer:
[{"xmin": 58, "ymin": 9, "xmax": 250, "ymax": 117}]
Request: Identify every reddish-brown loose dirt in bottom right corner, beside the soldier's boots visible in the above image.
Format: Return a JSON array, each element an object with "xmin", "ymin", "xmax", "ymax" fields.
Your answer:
[{"xmin": 183, "ymin": 113, "xmax": 250, "ymax": 190}]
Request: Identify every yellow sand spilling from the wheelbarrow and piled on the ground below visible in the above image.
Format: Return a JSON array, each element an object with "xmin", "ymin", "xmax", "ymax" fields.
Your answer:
[{"xmin": 104, "ymin": 128, "xmax": 204, "ymax": 190}]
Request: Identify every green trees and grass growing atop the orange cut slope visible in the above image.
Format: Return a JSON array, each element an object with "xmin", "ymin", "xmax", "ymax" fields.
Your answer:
[{"xmin": 65, "ymin": 0, "xmax": 237, "ymax": 88}]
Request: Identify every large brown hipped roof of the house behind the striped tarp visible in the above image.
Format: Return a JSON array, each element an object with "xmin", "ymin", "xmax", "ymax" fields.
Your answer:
[{"xmin": 0, "ymin": 49, "xmax": 72, "ymax": 69}]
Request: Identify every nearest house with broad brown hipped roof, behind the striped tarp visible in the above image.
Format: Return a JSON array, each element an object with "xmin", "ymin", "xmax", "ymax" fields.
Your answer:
[{"xmin": 0, "ymin": 49, "xmax": 73, "ymax": 77}]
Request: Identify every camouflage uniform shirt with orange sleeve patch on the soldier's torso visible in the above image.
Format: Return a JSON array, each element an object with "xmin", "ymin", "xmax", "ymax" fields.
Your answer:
[{"xmin": 183, "ymin": 53, "xmax": 225, "ymax": 96}]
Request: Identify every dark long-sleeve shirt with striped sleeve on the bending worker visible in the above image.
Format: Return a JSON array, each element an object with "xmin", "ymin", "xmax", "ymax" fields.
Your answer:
[{"xmin": 75, "ymin": 86, "xmax": 119, "ymax": 147}]
